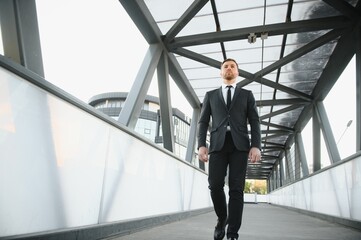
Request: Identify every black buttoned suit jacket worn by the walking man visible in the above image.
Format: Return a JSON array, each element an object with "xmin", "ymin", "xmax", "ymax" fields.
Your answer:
[{"xmin": 198, "ymin": 86, "xmax": 261, "ymax": 153}]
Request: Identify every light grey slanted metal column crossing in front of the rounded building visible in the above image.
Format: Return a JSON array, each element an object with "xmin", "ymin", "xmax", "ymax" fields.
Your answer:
[{"xmin": 118, "ymin": 44, "xmax": 162, "ymax": 129}]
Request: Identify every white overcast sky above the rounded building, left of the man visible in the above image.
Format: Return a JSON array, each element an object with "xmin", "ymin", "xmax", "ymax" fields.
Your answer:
[{"xmin": 36, "ymin": 0, "xmax": 192, "ymax": 116}]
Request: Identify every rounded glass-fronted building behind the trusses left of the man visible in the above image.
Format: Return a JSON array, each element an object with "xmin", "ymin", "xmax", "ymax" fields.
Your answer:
[{"xmin": 89, "ymin": 92, "xmax": 200, "ymax": 169}]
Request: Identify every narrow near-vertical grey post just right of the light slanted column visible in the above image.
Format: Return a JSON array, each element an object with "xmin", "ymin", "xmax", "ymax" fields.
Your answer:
[{"xmin": 157, "ymin": 52, "xmax": 174, "ymax": 152}]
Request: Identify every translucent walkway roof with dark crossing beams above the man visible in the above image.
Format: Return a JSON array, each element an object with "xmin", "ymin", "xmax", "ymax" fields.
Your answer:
[{"xmin": 120, "ymin": 0, "xmax": 361, "ymax": 179}]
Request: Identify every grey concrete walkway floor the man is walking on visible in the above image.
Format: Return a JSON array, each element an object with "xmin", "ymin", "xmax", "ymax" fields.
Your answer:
[{"xmin": 108, "ymin": 203, "xmax": 361, "ymax": 240}]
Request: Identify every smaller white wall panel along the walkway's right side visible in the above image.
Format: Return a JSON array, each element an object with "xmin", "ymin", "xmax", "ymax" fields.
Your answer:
[{"xmin": 269, "ymin": 155, "xmax": 361, "ymax": 221}]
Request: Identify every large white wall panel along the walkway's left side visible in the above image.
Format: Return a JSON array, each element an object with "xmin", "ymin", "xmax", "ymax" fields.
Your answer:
[{"xmin": 0, "ymin": 68, "xmax": 212, "ymax": 237}]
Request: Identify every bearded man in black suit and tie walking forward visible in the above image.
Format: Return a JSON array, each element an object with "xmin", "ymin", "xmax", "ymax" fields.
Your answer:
[{"xmin": 198, "ymin": 59, "xmax": 261, "ymax": 240}]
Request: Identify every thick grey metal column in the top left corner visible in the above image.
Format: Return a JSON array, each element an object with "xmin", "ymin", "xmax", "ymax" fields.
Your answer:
[{"xmin": 0, "ymin": 0, "xmax": 44, "ymax": 77}]
